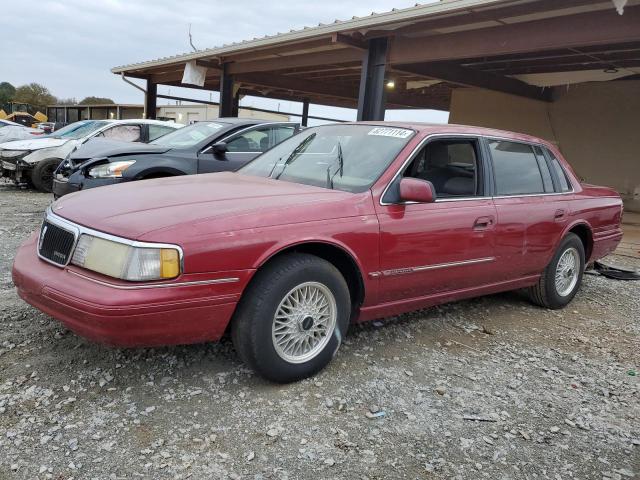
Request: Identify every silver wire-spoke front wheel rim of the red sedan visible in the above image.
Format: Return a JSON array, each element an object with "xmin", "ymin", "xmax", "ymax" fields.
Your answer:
[{"xmin": 271, "ymin": 282, "xmax": 337, "ymax": 363}]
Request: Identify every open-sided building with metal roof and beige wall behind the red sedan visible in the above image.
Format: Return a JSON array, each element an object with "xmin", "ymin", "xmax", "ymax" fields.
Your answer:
[{"xmin": 112, "ymin": 0, "xmax": 640, "ymax": 211}]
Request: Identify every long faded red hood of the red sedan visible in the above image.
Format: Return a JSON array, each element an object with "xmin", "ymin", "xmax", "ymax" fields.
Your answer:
[{"xmin": 52, "ymin": 172, "xmax": 373, "ymax": 243}]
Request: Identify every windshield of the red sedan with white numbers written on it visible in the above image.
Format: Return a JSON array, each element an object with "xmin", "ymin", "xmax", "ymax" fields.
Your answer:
[{"xmin": 239, "ymin": 125, "xmax": 414, "ymax": 193}]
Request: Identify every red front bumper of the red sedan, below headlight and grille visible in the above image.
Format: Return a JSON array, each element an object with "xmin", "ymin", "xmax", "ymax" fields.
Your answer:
[{"xmin": 12, "ymin": 233, "xmax": 250, "ymax": 347}]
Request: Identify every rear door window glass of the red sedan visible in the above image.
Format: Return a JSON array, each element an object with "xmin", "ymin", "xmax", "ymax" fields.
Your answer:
[{"xmin": 489, "ymin": 140, "xmax": 545, "ymax": 195}]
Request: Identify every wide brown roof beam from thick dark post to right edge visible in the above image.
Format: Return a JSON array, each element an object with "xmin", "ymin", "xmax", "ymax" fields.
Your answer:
[{"xmin": 389, "ymin": 6, "xmax": 640, "ymax": 65}]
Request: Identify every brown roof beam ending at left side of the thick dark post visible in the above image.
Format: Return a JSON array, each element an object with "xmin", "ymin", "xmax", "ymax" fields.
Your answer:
[{"xmin": 229, "ymin": 48, "xmax": 363, "ymax": 75}]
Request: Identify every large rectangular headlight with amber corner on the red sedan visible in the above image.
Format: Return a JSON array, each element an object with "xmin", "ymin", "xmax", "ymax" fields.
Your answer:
[{"xmin": 71, "ymin": 234, "xmax": 180, "ymax": 281}]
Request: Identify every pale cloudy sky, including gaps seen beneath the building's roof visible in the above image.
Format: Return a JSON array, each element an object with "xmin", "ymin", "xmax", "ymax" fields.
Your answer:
[{"xmin": 0, "ymin": 0, "xmax": 448, "ymax": 122}]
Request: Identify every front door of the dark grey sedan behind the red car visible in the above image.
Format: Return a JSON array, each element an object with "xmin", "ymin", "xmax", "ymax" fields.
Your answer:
[{"xmin": 198, "ymin": 123, "xmax": 298, "ymax": 173}]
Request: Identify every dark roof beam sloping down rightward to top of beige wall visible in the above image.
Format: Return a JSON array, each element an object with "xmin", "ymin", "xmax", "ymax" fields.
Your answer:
[{"xmin": 393, "ymin": 62, "xmax": 552, "ymax": 102}]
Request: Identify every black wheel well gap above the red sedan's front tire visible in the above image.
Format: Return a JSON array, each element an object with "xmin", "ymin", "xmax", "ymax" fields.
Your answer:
[{"xmin": 260, "ymin": 242, "xmax": 364, "ymax": 313}]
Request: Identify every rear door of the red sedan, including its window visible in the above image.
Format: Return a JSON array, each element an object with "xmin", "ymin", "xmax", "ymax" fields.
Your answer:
[{"xmin": 486, "ymin": 138, "xmax": 568, "ymax": 280}]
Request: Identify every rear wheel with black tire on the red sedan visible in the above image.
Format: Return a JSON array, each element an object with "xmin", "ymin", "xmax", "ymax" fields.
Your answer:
[{"xmin": 528, "ymin": 233, "xmax": 585, "ymax": 310}]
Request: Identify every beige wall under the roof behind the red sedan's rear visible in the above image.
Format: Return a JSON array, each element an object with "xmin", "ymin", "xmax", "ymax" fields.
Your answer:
[{"xmin": 449, "ymin": 80, "xmax": 640, "ymax": 211}]
